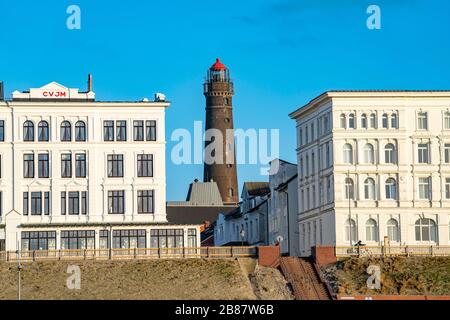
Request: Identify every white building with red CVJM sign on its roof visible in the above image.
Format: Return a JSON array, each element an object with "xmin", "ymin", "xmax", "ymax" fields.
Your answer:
[{"xmin": 0, "ymin": 82, "xmax": 200, "ymax": 250}]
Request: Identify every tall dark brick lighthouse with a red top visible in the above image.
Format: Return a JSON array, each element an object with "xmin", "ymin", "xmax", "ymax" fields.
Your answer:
[{"xmin": 203, "ymin": 59, "xmax": 239, "ymax": 204}]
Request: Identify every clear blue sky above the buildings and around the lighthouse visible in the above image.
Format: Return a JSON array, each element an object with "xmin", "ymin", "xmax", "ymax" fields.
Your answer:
[{"xmin": 0, "ymin": 0, "xmax": 450, "ymax": 200}]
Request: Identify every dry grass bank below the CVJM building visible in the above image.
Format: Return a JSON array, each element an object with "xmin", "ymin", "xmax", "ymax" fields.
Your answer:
[{"xmin": 0, "ymin": 259, "xmax": 255, "ymax": 300}]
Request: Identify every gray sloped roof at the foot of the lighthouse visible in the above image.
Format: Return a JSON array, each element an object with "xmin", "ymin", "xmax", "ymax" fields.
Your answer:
[{"xmin": 186, "ymin": 181, "xmax": 223, "ymax": 206}]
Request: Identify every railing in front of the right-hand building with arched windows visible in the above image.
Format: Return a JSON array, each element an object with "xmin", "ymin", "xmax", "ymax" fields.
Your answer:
[{"xmin": 335, "ymin": 246, "xmax": 450, "ymax": 258}]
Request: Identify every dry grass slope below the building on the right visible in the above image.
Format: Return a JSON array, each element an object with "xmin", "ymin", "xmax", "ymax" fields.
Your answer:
[{"xmin": 324, "ymin": 257, "xmax": 450, "ymax": 295}]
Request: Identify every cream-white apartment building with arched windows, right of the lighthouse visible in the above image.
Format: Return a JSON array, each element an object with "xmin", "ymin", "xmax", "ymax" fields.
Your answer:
[{"xmin": 290, "ymin": 91, "xmax": 450, "ymax": 255}]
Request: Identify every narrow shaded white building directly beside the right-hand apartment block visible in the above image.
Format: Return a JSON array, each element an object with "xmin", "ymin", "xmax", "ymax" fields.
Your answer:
[{"xmin": 267, "ymin": 159, "xmax": 300, "ymax": 256}]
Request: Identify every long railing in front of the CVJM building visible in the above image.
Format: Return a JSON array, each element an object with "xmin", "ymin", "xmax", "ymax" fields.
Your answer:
[{"xmin": 0, "ymin": 247, "xmax": 258, "ymax": 262}]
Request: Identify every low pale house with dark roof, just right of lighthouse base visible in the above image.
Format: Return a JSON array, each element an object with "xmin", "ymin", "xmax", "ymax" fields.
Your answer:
[{"xmin": 214, "ymin": 182, "xmax": 270, "ymax": 246}]
